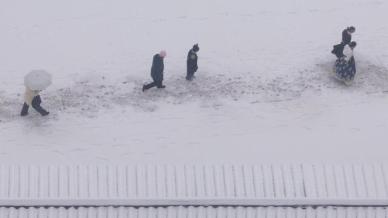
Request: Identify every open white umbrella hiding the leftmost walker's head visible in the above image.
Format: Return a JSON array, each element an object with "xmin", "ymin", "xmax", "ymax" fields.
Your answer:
[{"xmin": 24, "ymin": 70, "xmax": 52, "ymax": 91}]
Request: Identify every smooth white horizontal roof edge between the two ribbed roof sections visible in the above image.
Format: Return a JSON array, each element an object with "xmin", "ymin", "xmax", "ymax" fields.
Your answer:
[{"xmin": 0, "ymin": 198, "xmax": 388, "ymax": 207}]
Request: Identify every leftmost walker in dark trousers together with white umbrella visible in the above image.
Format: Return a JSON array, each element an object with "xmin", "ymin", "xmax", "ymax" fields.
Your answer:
[{"xmin": 20, "ymin": 70, "xmax": 52, "ymax": 116}]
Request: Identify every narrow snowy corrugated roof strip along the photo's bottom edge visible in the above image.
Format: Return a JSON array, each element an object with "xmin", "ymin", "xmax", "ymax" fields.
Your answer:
[{"xmin": 0, "ymin": 207, "xmax": 388, "ymax": 218}]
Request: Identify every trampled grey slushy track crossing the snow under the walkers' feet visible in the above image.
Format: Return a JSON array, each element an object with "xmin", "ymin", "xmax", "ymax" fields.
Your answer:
[{"xmin": 0, "ymin": 58, "xmax": 388, "ymax": 122}]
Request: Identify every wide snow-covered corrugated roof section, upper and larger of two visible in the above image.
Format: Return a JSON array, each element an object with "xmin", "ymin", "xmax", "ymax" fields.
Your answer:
[{"xmin": 0, "ymin": 164, "xmax": 388, "ymax": 206}]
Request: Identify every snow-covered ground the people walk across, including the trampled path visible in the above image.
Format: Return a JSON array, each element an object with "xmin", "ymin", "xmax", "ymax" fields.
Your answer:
[{"xmin": 0, "ymin": 0, "xmax": 388, "ymax": 163}]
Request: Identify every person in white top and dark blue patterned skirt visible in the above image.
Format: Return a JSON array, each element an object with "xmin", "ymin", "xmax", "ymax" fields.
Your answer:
[{"xmin": 334, "ymin": 42, "xmax": 357, "ymax": 85}]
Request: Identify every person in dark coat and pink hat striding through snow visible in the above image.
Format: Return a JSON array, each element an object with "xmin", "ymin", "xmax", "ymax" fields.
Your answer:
[{"xmin": 143, "ymin": 50, "xmax": 167, "ymax": 92}]
